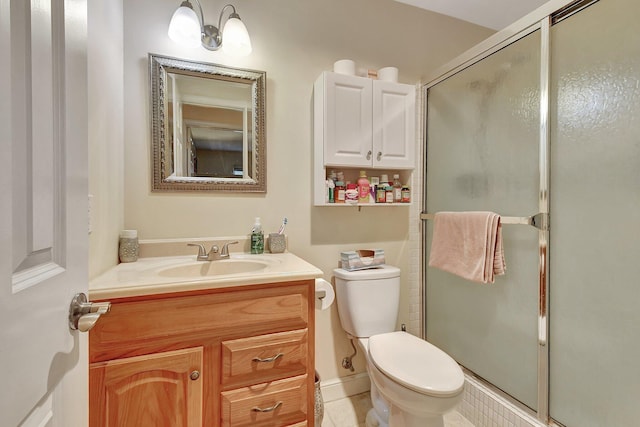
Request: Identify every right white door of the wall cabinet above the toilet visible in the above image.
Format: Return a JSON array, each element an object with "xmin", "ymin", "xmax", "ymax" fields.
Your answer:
[{"xmin": 373, "ymin": 80, "xmax": 416, "ymax": 169}]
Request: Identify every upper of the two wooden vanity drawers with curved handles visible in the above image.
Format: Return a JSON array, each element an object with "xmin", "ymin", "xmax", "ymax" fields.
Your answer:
[{"xmin": 222, "ymin": 329, "xmax": 309, "ymax": 389}]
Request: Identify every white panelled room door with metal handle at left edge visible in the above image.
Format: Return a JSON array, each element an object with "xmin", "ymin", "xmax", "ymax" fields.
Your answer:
[{"xmin": 0, "ymin": 0, "xmax": 88, "ymax": 427}]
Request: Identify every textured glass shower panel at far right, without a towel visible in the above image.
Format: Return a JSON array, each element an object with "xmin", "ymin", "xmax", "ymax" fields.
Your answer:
[{"xmin": 550, "ymin": 0, "xmax": 640, "ymax": 427}]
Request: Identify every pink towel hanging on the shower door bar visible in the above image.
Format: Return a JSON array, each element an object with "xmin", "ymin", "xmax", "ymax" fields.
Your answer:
[{"xmin": 429, "ymin": 212, "xmax": 507, "ymax": 283}]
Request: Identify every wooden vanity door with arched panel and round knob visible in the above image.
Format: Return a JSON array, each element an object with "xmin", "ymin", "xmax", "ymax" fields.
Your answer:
[{"xmin": 89, "ymin": 347, "xmax": 202, "ymax": 427}]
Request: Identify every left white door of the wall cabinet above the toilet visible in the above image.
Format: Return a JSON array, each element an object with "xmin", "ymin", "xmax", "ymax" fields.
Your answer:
[{"xmin": 324, "ymin": 73, "xmax": 372, "ymax": 166}]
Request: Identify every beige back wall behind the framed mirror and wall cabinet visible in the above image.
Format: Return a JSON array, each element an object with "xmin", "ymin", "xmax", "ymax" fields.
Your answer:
[{"xmin": 91, "ymin": 0, "xmax": 492, "ymax": 388}]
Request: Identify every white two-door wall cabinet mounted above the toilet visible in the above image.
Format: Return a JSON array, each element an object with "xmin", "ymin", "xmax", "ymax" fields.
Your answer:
[{"xmin": 314, "ymin": 71, "xmax": 416, "ymax": 205}]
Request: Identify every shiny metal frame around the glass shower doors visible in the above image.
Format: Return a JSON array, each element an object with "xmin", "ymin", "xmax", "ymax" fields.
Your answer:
[{"xmin": 421, "ymin": 0, "xmax": 599, "ymax": 424}]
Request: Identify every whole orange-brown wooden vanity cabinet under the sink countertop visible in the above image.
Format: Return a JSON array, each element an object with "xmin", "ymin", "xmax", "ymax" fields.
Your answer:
[{"xmin": 89, "ymin": 280, "xmax": 315, "ymax": 427}]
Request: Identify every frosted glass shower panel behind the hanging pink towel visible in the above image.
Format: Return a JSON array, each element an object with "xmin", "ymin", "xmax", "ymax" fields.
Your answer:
[{"xmin": 425, "ymin": 31, "xmax": 541, "ymax": 410}]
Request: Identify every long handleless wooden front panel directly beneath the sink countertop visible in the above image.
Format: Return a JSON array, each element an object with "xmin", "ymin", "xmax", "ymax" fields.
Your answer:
[{"xmin": 89, "ymin": 282, "xmax": 310, "ymax": 362}]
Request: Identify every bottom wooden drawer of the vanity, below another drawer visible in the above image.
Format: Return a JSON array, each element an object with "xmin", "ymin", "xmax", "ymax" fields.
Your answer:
[{"xmin": 221, "ymin": 375, "xmax": 307, "ymax": 427}]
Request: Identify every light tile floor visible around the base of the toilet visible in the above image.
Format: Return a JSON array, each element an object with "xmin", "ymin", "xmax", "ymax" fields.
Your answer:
[{"xmin": 322, "ymin": 393, "xmax": 474, "ymax": 427}]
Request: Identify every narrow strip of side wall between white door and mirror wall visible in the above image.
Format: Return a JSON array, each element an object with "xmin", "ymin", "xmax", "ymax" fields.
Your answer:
[{"xmin": 87, "ymin": 0, "xmax": 124, "ymax": 277}]
